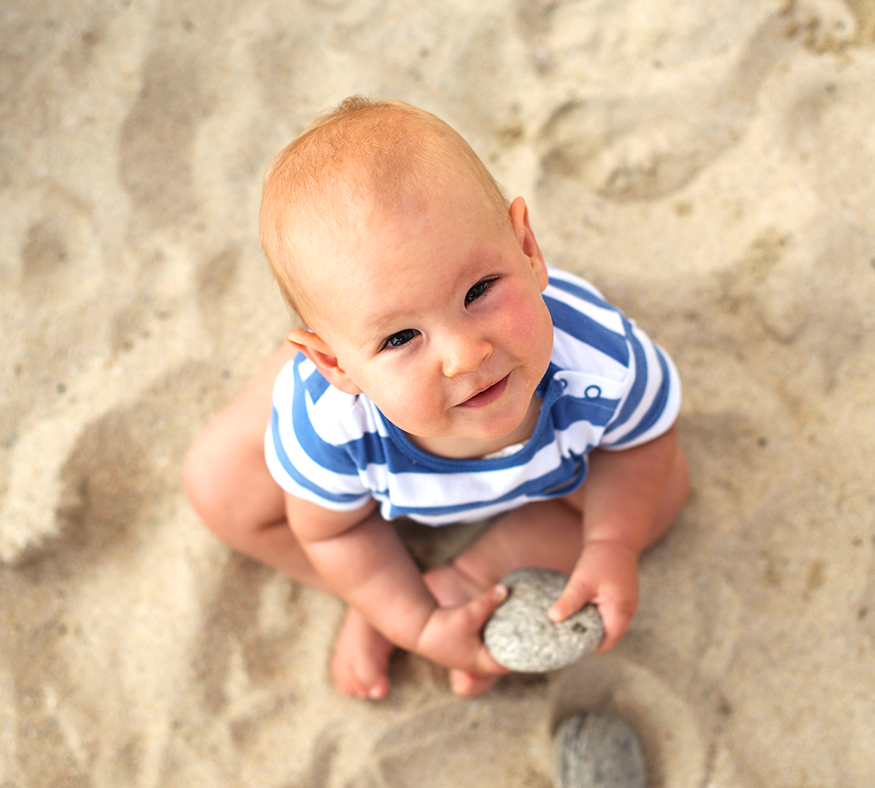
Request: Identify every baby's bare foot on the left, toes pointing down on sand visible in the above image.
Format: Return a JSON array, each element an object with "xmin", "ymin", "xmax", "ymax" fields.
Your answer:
[{"xmin": 331, "ymin": 608, "xmax": 395, "ymax": 700}]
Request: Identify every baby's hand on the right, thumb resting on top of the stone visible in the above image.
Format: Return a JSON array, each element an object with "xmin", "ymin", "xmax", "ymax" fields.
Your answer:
[{"xmin": 547, "ymin": 541, "xmax": 638, "ymax": 651}]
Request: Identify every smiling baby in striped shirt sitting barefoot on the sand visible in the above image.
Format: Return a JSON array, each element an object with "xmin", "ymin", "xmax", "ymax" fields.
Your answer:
[{"xmin": 184, "ymin": 98, "xmax": 688, "ymax": 699}]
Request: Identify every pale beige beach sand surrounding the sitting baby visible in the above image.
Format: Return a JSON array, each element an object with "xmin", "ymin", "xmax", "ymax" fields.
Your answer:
[{"xmin": 0, "ymin": 0, "xmax": 875, "ymax": 788}]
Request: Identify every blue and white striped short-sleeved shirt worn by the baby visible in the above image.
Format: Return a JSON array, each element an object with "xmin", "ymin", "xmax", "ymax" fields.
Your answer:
[{"xmin": 265, "ymin": 268, "xmax": 681, "ymax": 525}]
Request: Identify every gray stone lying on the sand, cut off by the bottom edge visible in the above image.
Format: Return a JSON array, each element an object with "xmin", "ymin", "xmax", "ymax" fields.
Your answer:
[{"xmin": 553, "ymin": 712, "xmax": 647, "ymax": 788}]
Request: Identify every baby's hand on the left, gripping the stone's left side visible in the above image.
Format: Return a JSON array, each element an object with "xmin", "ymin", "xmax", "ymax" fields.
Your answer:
[{"xmin": 412, "ymin": 585, "xmax": 510, "ymax": 674}]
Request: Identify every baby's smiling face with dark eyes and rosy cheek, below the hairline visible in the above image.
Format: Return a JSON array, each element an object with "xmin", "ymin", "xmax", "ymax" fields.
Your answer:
[{"xmin": 314, "ymin": 175, "xmax": 553, "ymax": 456}]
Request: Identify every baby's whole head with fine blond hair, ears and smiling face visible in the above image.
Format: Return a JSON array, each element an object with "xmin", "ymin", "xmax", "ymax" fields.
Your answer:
[{"xmin": 261, "ymin": 99, "xmax": 553, "ymax": 456}]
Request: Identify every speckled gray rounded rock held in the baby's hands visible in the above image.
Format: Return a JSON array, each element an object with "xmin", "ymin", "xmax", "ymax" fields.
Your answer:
[{"xmin": 483, "ymin": 568, "xmax": 604, "ymax": 673}]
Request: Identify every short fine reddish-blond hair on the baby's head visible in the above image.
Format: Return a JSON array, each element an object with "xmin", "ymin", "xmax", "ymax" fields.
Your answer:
[{"xmin": 259, "ymin": 96, "xmax": 509, "ymax": 322}]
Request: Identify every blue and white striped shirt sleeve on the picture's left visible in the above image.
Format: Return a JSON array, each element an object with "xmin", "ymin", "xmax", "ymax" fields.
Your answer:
[{"xmin": 264, "ymin": 355, "xmax": 371, "ymax": 511}]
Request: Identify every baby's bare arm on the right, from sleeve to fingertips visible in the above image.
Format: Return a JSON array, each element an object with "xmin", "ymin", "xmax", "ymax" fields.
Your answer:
[{"xmin": 549, "ymin": 427, "xmax": 686, "ymax": 651}]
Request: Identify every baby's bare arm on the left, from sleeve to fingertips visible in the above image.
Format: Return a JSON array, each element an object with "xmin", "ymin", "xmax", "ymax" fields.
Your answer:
[{"xmin": 286, "ymin": 495, "xmax": 507, "ymax": 673}]
